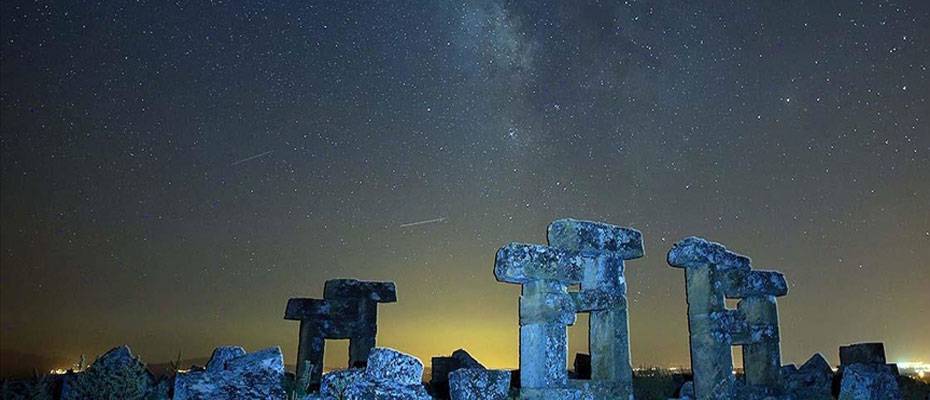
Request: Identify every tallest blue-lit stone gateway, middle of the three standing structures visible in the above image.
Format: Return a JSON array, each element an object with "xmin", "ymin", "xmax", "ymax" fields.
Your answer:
[{"xmin": 494, "ymin": 219, "xmax": 643, "ymax": 399}]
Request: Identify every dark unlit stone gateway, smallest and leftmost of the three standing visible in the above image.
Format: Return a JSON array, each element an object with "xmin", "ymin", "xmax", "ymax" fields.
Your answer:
[{"xmin": 284, "ymin": 279, "xmax": 397, "ymax": 387}]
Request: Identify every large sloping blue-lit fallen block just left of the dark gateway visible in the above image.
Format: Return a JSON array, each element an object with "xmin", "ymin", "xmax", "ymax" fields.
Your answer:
[{"xmin": 174, "ymin": 347, "xmax": 287, "ymax": 400}]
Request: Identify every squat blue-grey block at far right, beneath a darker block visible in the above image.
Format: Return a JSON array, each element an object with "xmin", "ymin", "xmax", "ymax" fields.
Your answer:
[{"xmin": 839, "ymin": 364, "xmax": 901, "ymax": 400}]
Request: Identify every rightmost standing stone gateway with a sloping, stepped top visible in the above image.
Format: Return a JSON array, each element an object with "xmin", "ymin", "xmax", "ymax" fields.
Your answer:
[{"xmin": 668, "ymin": 237, "xmax": 788, "ymax": 399}]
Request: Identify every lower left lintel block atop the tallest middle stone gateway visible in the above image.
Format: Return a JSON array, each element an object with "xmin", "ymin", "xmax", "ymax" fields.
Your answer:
[{"xmin": 494, "ymin": 243, "xmax": 584, "ymax": 285}]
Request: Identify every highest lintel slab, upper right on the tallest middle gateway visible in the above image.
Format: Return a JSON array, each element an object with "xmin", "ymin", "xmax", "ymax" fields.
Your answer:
[{"xmin": 548, "ymin": 218, "xmax": 644, "ymax": 260}]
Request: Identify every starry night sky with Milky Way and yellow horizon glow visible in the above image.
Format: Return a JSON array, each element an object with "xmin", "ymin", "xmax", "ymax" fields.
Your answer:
[{"xmin": 0, "ymin": 0, "xmax": 930, "ymax": 374}]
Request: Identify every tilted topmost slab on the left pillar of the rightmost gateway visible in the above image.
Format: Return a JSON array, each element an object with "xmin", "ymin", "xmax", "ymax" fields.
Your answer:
[{"xmin": 667, "ymin": 236, "xmax": 751, "ymax": 270}]
